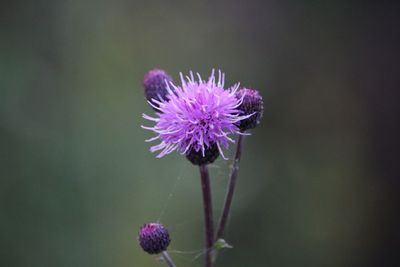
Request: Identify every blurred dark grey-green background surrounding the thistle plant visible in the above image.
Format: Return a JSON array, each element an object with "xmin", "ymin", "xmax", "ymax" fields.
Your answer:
[{"xmin": 0, "ymin": 0, "xmax": 400, "ymax": 267}]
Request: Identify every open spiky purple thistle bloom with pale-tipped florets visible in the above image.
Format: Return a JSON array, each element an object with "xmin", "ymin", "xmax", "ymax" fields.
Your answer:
[{"xmin": 142, "ymin": 70, "xmax": 251, "ymax": 160}]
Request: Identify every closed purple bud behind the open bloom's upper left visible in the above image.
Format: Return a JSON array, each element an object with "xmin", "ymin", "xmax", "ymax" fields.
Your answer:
[{"xmin": 143, "ymin": 69, "xmax": 172, "ymax": 110}]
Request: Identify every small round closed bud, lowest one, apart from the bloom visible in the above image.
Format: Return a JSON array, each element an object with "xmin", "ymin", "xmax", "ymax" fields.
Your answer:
[{"xmin": 139, "ymin": 223, "xmax": 171, "ymax": 254}]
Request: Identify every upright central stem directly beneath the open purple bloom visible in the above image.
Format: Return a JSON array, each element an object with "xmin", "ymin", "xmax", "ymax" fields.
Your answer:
[{"xmin": 200, "ymin": 165, "xmax": 214, "ymax": 267}]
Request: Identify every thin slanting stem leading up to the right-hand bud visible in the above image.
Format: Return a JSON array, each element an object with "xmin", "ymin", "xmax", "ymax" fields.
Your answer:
[{"xmin": 215, "ymin": 135, "xmax": 244, "ymax": 240}]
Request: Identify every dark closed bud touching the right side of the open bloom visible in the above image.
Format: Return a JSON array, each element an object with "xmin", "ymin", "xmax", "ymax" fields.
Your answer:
[{"xmin": 236, "ymin": 88, "xmax": 264, "ymax": 131}]
